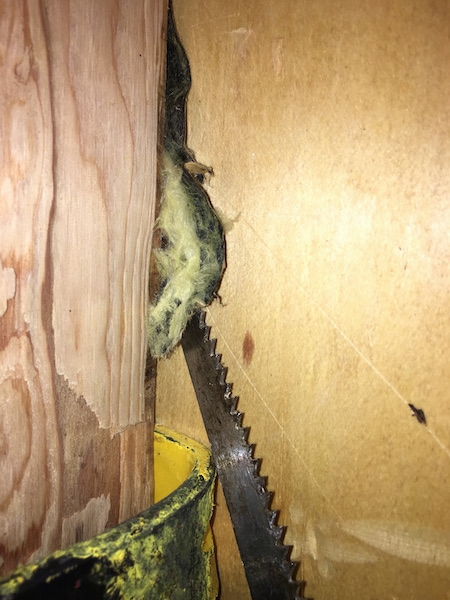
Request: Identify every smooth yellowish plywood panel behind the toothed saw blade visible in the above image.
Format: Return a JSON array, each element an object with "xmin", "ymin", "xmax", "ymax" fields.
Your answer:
[{"xmin": 156, "ymin": 0, "xmax": 450, "ymax": 600}]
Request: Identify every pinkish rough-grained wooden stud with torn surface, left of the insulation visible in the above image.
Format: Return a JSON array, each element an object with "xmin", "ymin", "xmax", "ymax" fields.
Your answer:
[{"xmin": 0, "ymin": 0, "xmax": 166, "ymax": 572}]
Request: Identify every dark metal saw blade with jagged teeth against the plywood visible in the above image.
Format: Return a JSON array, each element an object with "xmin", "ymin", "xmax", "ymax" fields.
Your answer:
[{"xmin": 181, "ymin": 311, "xmax": 301, "ymax": 600}]
